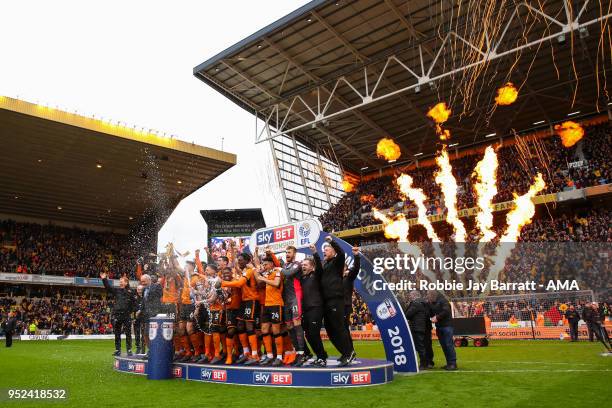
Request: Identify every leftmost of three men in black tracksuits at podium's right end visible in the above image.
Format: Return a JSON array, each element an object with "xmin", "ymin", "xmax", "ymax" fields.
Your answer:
[{"xmin": 300, "ymin": 245, "xmax": 327, "ymax": 367}]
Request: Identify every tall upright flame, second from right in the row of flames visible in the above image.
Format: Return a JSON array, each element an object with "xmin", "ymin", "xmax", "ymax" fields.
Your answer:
[{"xmin": 473, "ymin": 146, "xmax": 499, "ymax": 242}]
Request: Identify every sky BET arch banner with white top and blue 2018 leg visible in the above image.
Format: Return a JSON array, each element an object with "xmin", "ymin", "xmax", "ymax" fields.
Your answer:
[{"xmin": 246, "ymin": 219, "xmax": 418, "ymax": 372}]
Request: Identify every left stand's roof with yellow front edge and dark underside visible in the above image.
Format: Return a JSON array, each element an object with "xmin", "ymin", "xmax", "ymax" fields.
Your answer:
[{"xmin": 0, "ymin": 96, "xmax": 236, "ymax": 230}]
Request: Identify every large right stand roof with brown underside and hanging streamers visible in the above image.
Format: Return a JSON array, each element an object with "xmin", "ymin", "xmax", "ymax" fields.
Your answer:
[{"xmin": 193, "ymin": 0, "xmax": 611, "ymax": 171}]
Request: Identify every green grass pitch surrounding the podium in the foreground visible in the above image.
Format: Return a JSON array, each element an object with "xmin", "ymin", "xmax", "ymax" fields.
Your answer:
[{"xmin": 0, "ymin": 340, "xmax": 612, "ymax": 408}]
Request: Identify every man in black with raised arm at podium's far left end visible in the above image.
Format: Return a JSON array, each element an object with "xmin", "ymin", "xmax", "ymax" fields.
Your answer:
[{"xmin": 100, "ymin": 272, "xmax": 134, "ymax": 356}]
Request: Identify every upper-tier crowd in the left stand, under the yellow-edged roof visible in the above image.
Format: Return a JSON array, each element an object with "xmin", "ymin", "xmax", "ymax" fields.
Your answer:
[{"xmin": 0, "ymin": 220, "xmax": 138, "ymax": 279}]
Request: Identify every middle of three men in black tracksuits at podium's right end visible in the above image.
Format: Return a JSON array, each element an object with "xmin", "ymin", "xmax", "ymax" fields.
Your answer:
[{"xmin": 320, "ymin": 235, "xmax": 355, "ymax": 367}]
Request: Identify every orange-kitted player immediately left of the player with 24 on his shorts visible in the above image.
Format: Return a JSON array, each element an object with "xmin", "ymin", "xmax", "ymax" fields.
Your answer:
[{"xmin": 222, "ymin": 253, "xmax": 260, "ymax": 365}]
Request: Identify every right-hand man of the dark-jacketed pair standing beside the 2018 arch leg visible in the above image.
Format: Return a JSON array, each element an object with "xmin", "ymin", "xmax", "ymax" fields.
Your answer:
[{"xmin": 427, "ymin": 290, "xmax": 457, "ymax": 371}]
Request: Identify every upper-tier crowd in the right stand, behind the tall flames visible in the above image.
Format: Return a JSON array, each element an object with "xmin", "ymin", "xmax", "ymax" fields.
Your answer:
[{"xmin": 320, "ymin": 122, "xmax": 612, "ymax": 231}]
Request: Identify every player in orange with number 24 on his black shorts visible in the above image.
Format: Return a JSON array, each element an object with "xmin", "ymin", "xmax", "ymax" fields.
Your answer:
[{"xmin": 255, "ymin": 256, "xmax": 283, "ymax": 366}]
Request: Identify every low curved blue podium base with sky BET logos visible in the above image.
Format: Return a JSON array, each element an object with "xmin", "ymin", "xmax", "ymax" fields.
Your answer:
[{"xmin": 114, "ymin": 356, "xmax": 393, "ymax": 388}]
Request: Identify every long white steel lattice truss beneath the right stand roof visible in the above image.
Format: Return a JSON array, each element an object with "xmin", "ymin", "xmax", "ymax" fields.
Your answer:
[{"xmin": 255, "ymin": 0, "xmax": 612, "ymax": 143}]
